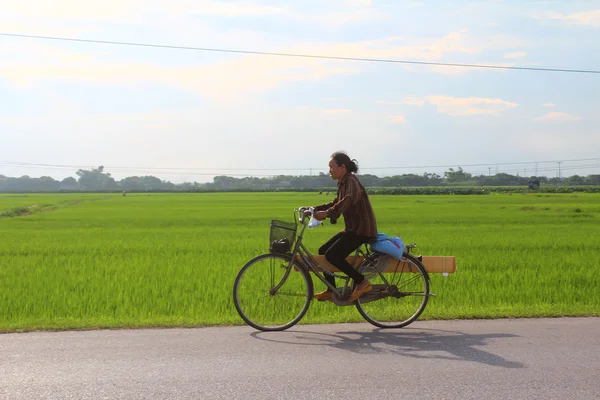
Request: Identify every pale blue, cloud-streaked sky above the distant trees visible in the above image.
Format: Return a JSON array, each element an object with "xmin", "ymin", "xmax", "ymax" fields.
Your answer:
[{"xmin": 0, "ymin": 0, "xmax": 600, "ymax": 183}]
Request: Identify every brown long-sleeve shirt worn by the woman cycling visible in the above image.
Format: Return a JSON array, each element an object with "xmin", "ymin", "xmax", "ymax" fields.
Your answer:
[{"xmin": 315, "ymin": 173, "xmax": 378, "ymax": 238}]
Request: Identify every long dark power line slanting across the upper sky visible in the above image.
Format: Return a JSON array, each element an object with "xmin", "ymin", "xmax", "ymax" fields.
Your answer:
[{"xmin": 0, "ymin": 32, "xmax": 600, "ymax": 74}]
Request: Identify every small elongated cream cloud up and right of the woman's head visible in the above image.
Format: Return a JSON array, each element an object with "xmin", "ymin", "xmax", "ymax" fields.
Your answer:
[{"xmin": 405, "ymin": 95, "xmax": 518, "ymax": 116}]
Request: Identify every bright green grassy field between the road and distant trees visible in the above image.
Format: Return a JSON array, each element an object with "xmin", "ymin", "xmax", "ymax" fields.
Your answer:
[{"xmin": 0, "ymin": 193, "xmax": 600, "ymax": 331}]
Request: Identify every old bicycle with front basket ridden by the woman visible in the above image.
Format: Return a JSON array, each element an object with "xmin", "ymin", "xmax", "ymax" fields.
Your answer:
[{"xmin": 233, "ymin": 207, "xmax": 435, "ymax": 331}]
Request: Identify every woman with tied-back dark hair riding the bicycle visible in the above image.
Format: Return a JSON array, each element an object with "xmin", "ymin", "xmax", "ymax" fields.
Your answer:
[{"xmin": 314, "ymin": 152, "xmax": 377, "ymax": 302}]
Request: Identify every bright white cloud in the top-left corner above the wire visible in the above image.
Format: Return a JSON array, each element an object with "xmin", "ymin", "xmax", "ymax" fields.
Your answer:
[{"xmin": 0, "ymin": 0, "xmax": 290, "ymax": 47}]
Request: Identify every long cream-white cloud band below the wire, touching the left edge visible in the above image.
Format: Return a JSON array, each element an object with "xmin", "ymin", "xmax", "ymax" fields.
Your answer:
[{"xmin": 0, "ymin": 40, "xmax": 356, "ymax": 102}]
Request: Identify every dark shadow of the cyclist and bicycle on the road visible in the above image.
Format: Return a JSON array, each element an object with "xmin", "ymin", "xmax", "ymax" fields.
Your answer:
[{"xmin": 251, "ymin": 328, "xmax": 525, "ymax": 368}]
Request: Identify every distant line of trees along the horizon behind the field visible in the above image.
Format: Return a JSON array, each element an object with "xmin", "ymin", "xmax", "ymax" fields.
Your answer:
[{"xmin": 0, "ymin": 166, "xmax": 600, "ymax": 192}]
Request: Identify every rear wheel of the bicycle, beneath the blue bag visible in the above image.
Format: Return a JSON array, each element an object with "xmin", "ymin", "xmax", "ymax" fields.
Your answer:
[{"xmin": 356, "ymin": 254, "xmax": 429, "ymax": 328}]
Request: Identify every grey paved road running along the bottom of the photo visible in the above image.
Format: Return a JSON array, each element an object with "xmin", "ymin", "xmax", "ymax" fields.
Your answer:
[{"xmin": 0, "ymin": 318, "xmax": 600, "ymax": 400}]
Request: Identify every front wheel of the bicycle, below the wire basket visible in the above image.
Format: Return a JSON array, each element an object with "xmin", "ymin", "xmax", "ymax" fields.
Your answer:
[{"xmin": 233, "ymin": 254, "xmax": 313, "ymax": 331}]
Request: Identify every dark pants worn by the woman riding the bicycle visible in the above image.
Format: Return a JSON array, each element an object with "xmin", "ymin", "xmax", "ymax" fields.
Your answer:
[{"xmin": 319, "ymin": 232, "xmax": 371, "ymax": 287}]
